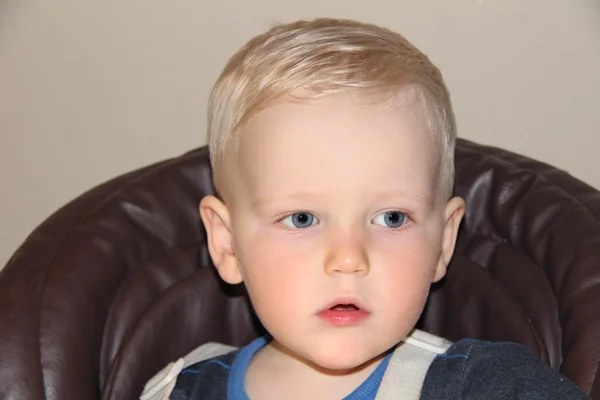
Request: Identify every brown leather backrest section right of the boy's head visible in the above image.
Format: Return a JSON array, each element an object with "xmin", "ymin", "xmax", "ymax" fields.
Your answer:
[{"xmin": 422, "ymin": 140, "xmax": 600, "ymax": 399}]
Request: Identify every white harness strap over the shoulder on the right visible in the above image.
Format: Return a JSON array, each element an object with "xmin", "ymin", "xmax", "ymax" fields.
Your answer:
[{"xmin": 375, "ymin": 329, "xmax": 452, "ymax": 400}]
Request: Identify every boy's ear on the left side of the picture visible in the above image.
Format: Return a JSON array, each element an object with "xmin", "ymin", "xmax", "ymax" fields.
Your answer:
[{"xmin": 200, "ymin": 196, "xmax": 243, "ymax": 285}]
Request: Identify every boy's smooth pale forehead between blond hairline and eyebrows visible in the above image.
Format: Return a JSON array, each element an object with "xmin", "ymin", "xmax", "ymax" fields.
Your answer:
[{"xmin": 230, "ymin": 95, "xmax": 437, "ymax": 206}]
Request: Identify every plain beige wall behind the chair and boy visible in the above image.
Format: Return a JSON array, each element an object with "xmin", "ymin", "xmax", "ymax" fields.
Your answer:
[{"xmin": 0, "ymin": 0, "xmax": 600, "ymax": 268}]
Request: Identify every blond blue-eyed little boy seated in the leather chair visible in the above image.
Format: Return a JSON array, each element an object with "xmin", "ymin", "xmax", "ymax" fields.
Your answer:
[{"xmin": 143, "ymin": 19, "xmax": 585, "ymax": 400}]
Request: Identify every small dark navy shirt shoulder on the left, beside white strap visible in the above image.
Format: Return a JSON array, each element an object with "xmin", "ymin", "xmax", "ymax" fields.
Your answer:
[{"xmin": 170, "ymin": 350, "xmax": 239, "ymax": 400}]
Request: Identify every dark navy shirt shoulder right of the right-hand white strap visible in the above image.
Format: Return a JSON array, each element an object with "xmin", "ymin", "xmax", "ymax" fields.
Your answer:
[{"xmin": 422, "ymin": 339, "xmax": 587, "ymax": 400}]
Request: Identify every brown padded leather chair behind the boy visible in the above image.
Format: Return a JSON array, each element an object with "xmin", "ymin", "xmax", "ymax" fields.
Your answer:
[{"xmin": 0, "ymin": 140, "xmax": 600, "ymax": 400}]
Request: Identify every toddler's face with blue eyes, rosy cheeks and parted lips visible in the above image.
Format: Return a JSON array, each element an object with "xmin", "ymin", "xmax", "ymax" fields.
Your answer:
[{"xmin": 204, "ymin": 95, "xmax": 462, "ymax": 370}]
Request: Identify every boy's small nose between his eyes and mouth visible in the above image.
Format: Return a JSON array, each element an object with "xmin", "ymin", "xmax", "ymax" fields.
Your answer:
[{"xmin": 325, "ymin": 231, "xmax": 370, "ymax": 276}]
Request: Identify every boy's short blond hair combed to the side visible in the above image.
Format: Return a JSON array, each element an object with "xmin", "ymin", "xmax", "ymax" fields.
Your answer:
[{"xmin": 208, "ymin": 19, "xmax": 456, "ymax": 200}]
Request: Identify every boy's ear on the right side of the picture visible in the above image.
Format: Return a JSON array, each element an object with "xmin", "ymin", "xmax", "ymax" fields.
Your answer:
[{"xmin": 433, "ymin": 197, "xmax": 465, "ymax": 282}]
